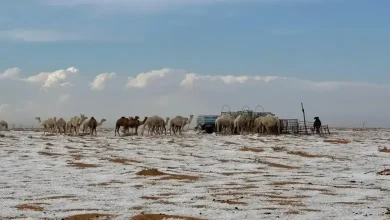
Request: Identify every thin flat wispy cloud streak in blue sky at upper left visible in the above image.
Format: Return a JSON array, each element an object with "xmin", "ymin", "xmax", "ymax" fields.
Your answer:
[{"xmin": 0, "ymin": 29, "xmax": 81, "ymax": 42}]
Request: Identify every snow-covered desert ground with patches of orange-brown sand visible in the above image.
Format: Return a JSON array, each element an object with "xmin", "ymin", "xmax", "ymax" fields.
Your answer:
[{"xmin": 0, "ymin": 129, "xmax": 390, "ymax": 220}]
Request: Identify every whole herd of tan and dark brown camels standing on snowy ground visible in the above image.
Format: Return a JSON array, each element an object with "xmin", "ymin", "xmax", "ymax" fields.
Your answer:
[{"xmin": 0, "ymin": 114, "xmax": 285, "ymax": 136}]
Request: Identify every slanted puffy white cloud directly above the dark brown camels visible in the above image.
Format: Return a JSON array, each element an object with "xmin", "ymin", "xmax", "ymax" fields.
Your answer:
[{"xmin": 126, "ymin": 68, "xmax": 174, "ymax": 88}]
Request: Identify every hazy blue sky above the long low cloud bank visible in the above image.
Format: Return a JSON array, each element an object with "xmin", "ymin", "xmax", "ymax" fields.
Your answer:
[{"xmin": 0, "ymin": 0, "xmax": 390, "ymax": 126}]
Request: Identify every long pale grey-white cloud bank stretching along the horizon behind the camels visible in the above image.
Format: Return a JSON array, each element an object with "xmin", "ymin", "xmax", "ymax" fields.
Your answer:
[{"xmin": 0, "ymin": 67, "xmax": 390, "ymax": 127}]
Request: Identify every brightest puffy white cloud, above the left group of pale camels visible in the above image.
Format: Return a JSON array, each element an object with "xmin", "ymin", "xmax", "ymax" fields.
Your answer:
[{"xmin": 22, "ymin": 67, "xmax": 79, "ymax": 91}]
